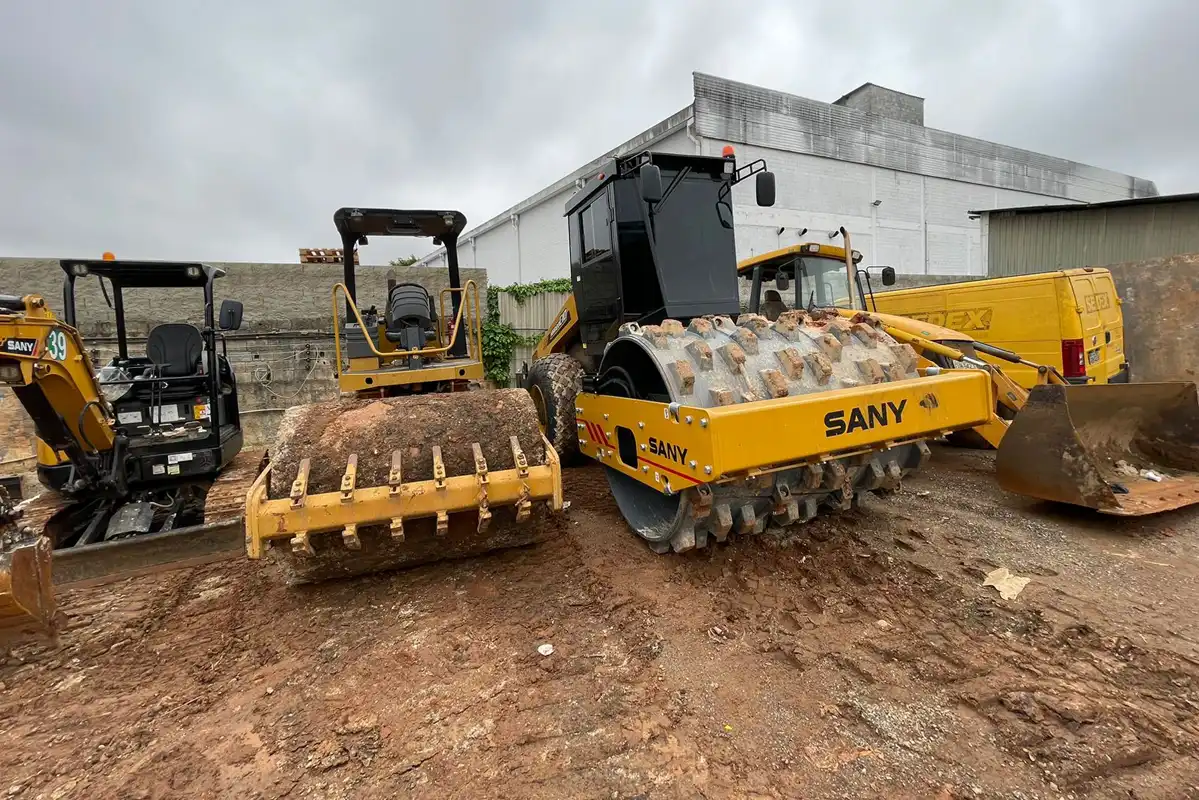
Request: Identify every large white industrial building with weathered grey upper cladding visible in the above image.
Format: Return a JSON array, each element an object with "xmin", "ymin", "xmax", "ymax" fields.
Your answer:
[{"xmin": 421, "ymin": 73, "xmax": 1157, "ymax": 285}]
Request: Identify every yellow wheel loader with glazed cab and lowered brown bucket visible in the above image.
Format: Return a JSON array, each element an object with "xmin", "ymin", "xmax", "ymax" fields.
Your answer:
[{"xmin": 739, "ymin": 241, "xmax": 1199, "ymax": 516}]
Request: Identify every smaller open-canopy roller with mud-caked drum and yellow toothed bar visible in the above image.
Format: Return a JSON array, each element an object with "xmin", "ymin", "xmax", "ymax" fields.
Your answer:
[{"xmin": 246, "ymin": 209, "xmax": 562, "ymax": 583}]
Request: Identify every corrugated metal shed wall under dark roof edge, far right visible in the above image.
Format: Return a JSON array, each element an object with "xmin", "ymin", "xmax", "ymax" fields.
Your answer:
[{"xmin": 987, "ymin": 200, "xmax": 1199, "ymax": 277}]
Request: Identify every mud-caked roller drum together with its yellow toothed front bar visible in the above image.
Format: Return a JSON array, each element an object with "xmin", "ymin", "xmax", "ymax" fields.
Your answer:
[{"xmin": 246, "ymin": 390, "xmax": 562, "ymax": 583}]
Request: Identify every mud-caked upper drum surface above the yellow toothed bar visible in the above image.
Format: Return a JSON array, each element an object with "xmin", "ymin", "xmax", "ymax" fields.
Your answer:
[{"xmin": 271, "ymin": 389, "xmax": 546, "ymax": 498}]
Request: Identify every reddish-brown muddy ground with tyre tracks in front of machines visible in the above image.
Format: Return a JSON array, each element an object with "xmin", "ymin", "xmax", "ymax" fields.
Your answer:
[{"xmin": 0, "ymin": 449, "xmax": 1199, "ymax": 800}]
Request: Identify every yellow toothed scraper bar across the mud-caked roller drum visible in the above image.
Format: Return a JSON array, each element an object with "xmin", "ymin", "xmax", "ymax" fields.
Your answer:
[{"xmin": 246, "ymin": 437, "xmax": 562, "ymax": 559}]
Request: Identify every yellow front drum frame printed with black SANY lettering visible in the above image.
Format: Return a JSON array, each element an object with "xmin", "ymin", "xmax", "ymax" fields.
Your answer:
[{"xmin": 576, "ymin": 369, "xmax": 994, "ymax": 494}]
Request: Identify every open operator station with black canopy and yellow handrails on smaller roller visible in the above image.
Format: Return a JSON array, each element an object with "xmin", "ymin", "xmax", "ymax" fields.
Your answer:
[{"xmin": 332, "ymin": 207, "xmax": 483, "ymax": 396}]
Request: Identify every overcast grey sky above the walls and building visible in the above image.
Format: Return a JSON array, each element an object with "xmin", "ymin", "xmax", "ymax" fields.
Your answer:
[{"xmin": 0, "ymin": 0, "xmax": 1199, "ymax": 263}]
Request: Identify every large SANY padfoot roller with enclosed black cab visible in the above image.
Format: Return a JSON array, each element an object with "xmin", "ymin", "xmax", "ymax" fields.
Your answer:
[{"xmin": 522, "ymin": 149, "xmax": 993, "ymax": 553}]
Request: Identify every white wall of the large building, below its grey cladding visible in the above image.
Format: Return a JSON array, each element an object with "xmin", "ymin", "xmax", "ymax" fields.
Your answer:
[{"xmin": 429, "ymin": 130, "xmax": 1112, "ymax": 285}]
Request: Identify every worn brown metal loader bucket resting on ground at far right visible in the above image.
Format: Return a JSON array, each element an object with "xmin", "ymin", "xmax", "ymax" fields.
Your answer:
[{"xmin": 995, "ymin": 381, "xmax": 1199, "ymax": 516}]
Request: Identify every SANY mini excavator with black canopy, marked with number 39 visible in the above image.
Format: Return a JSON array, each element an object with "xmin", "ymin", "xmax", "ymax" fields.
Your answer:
[{"xmin": 0, "ymin": 259, "xmax": 258, "ymax": 627}]
